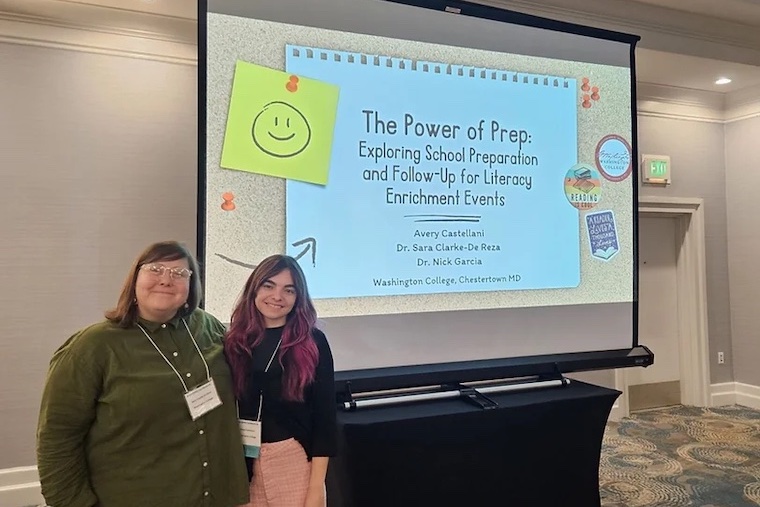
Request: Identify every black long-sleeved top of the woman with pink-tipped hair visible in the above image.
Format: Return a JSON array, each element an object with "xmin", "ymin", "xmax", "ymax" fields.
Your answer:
[{"xmin": 239, "ymin": 327, "xmax": 337, "ymax": 470}]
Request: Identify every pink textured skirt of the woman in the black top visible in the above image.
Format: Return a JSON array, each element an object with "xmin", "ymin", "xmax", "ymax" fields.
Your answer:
[{"xmin": 238, "ymin": 438, "xmax": 320, "ymax": 507}]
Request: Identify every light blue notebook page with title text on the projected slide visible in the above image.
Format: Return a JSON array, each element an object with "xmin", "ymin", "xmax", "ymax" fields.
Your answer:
[{"xmin": 285, "ymin": 45, "xmax": 580, "ymax": 299}]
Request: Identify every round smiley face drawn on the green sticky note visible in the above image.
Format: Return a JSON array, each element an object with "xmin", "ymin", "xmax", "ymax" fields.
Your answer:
[{"xmin": 251, "ymin": 100, "xmax": 311, "ymax": 158}]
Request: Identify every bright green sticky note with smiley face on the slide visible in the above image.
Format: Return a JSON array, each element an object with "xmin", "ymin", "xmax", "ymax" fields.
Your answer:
[{"xmin": 221, "ymin": 61, "xmax": 339, "ymax": 185}]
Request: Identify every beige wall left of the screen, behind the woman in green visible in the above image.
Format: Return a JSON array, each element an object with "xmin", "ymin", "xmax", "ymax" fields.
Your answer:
[{"xmin": 0, "ymin": 43, "xmax": 197, "ymax": 469}]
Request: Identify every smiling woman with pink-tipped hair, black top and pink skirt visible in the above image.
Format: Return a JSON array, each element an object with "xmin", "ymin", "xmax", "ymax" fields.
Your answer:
[{"xmin": 225, "ymin": 255, "xmax": 337, "ymax": 507}]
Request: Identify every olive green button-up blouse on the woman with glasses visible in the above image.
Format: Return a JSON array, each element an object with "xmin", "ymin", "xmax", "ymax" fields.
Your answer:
[{"xmin": 37, "ymin": 309, "xmax": 248, "ymax": 507}]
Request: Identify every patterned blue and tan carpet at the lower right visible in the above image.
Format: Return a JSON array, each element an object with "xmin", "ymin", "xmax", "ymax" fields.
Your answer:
[{"xmin": 599, "ymin": 406, "xmax": 760, "ymax": 507}]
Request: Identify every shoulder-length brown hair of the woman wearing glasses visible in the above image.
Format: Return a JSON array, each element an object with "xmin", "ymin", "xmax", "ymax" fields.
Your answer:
[{"xmin": 106, "ymin": 241, "xmax": 203, "ymax": 328}]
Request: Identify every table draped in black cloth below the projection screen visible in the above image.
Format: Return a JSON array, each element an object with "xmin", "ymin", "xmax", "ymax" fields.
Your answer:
[{"xmin": 327, "ymin": 381, "xmax": 621, "ymax": 507}]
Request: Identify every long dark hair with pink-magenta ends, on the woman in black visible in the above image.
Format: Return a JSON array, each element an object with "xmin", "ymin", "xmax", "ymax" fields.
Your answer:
[{"xmin": 224, "ymin": 255, "xmax": 319, "ymax": 401}]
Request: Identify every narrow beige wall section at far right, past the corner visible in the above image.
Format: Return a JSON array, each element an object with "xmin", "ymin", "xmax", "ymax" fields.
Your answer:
[{"xmin": 726, "ymin": 117, "xmax": 760, "ymax": 386}]
